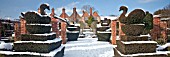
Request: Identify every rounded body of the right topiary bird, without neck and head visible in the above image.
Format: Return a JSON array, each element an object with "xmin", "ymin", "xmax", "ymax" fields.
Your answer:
[{"xmin": 126, "ymin": 9, "xmax": 145, "ymax": 24}]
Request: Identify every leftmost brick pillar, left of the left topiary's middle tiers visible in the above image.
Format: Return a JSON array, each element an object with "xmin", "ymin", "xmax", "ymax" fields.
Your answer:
[{"xmin": 14, "ymin": 22, "xmax": 21, "ymax": 42}]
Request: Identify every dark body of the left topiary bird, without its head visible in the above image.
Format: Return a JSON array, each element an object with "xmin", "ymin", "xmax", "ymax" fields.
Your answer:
[{"xmin": 24, "ymin": 12, "xmax": 51, "ymax": 24}]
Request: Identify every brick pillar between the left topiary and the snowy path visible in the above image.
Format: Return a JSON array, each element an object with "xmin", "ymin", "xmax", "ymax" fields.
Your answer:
[{"xmin": 61, "ymin": 22, "xmax": 66, "ymax": 44}]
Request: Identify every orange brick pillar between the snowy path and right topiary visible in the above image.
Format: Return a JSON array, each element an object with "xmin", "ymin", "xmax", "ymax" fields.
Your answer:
[{"xmin": 111, "ymin": 20, "xmax": 116, "ymax": 45}]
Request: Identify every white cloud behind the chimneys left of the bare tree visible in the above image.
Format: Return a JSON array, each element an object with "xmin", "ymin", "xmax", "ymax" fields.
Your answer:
[{"xmin": 55, "ymin": 2, "xmax": 81, "ymax": 16}]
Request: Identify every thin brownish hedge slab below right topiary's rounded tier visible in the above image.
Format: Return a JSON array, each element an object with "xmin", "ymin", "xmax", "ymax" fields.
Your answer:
[{"xmin": 120, "ymin": 35, "xmax": 148, "ymax": 41}]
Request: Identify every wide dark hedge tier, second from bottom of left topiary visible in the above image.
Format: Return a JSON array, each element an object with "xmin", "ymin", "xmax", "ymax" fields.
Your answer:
[{"xmin": 14, "ymin": 41, "xmax": 62, "ymax": 53}]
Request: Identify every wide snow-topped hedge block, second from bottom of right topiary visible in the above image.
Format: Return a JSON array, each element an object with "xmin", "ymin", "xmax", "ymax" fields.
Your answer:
[{"xmin": 116, "ymin": 40, "xmax": 157, "ymax": 54}]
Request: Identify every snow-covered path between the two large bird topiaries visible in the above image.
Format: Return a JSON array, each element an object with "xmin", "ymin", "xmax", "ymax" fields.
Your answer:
[{"xmin": 64, "ymin": 36, "xmax": 114, "ymax": 57}]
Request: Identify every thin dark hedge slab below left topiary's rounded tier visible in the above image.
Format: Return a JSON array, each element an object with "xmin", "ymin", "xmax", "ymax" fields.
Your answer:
[{"xmin": 21, "ymin": 34, "xmax": 56, "ymax": 41}]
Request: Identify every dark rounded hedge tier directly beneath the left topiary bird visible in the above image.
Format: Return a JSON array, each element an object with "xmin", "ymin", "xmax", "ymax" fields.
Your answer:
[{"xmin": 26, "ymin": 25, "xmax": 51, "ymax": 34}]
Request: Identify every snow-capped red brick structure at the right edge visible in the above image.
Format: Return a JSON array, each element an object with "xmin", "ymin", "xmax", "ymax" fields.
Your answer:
[{"xmin": 151, "ymin": 15, "xmax": 170, "ymax": 42}]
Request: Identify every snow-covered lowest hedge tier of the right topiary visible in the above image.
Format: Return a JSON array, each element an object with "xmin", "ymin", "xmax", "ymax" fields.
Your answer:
[{"xmin": 114, "ymin": 48, "xmax": 167, "ymax": 57}]
